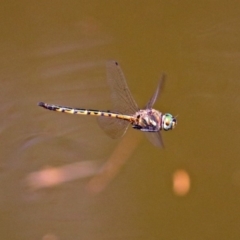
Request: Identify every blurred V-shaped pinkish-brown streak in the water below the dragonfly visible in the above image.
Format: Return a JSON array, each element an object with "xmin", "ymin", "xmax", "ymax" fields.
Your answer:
[{"xmin": 25, "ymin": 131, "xmax": 141, "ymax": 194}]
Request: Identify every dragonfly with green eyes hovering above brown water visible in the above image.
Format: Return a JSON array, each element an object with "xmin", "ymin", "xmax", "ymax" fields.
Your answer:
[{"xmin": 38, "ymin": 61, "xmax": 177, "ymax": 147}]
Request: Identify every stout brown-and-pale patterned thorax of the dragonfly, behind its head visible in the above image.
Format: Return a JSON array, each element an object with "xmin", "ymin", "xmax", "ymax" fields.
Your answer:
[{"xmin": 132, "ymin": 109, "xmax": 162, "ymax": 132}]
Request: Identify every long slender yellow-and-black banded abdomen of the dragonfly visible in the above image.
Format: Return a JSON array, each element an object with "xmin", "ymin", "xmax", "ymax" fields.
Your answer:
[{"xmin": 38, "ymin": 102, "xmax": 135, "ymax": 123}]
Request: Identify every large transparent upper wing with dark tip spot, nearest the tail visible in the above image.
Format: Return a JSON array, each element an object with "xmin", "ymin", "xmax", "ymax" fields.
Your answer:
[{"xmin": 107, "ymin": 61, "xmax": 139, "ymax": 114}]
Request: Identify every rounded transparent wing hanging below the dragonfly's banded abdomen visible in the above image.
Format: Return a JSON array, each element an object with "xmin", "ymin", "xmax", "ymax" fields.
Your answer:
[{"xmin": 97, "ymin": 116, "xmax": 129, "ymax": 138}]
